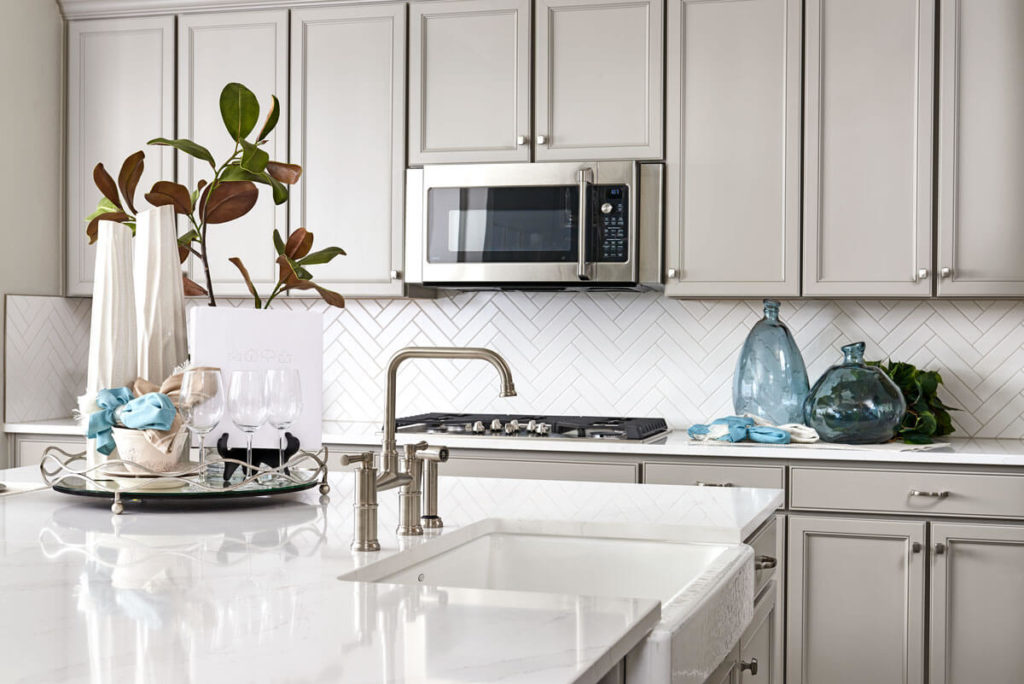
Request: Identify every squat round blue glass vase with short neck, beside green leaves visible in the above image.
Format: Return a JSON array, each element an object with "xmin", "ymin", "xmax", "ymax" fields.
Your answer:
[{"xmin": 804, "ymin": 342, "xmax": 906, "ymax": 444}]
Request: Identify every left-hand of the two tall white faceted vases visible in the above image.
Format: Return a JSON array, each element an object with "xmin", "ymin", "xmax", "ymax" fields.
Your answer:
[{"xmin": 80, "ymin": 221, "xmax": 137, "ymax": 465}]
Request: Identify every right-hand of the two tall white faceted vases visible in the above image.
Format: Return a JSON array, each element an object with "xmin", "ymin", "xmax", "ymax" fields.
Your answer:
[{"xmin": 134, "ymin": 205, "xmax": 188, "ymax": 385}]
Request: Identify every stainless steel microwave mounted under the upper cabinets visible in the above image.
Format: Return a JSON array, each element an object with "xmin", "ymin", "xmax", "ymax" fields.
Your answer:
[{"xmin": 406, "ymin": 162, "xmax": 665, "ymax": 289}]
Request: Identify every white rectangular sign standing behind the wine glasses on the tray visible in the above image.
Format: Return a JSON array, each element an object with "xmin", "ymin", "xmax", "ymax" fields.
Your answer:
[{"xmin": 188, "ymin": 306, "xmax": 324, "ymax": 451}]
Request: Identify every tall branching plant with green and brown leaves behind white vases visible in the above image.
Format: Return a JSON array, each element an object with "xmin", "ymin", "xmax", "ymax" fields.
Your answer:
[{"xmin": 86, "ymin": 83, "xmax": 345, "ymax": 308}]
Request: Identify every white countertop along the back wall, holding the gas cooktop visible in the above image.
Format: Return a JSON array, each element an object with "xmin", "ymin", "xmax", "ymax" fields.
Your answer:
[{"xmin": 4, "ymin": 418, "xmax": 1024, "ymax": 467}]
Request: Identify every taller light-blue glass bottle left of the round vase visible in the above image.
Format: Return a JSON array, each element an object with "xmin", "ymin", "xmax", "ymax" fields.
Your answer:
[{"xmin": 732, "ymin": 299, "xmax": 808, "ymax": 425}]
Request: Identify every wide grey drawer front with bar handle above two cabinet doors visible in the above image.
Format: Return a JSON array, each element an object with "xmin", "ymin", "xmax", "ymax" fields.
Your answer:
[{"xmin": 790, "ymin": 467, "xmax": 1024, "ymax": 518}]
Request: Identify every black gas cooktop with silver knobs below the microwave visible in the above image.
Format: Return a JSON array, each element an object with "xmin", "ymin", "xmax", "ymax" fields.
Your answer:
[{"xmin": 395, "ymin": 414, "xmax": 669, "ymax": 442}]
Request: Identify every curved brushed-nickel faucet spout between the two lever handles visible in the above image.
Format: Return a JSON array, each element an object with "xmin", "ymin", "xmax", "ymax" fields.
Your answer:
[{"xmin": 377, "ymin": 347, "xmax": 516, "ymax": 481}]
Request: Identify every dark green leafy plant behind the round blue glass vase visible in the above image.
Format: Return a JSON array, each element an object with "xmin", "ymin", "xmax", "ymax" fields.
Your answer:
[{"xmin": 867, "ymin": 360, "xmax": 957, "ymax": 444}]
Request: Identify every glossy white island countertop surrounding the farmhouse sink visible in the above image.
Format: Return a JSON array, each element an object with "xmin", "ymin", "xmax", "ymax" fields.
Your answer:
[{"xmin": 0, "ymin": 468, "xmax": 782, "ymax": 683}]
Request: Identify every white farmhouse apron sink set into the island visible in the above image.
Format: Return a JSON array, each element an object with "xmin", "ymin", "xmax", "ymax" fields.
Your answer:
[{"xmin": 340, "ymin": 520, "xmax": 754, "ymax": 684}]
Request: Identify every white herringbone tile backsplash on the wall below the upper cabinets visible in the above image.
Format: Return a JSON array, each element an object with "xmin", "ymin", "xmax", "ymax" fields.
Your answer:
[{"xmin": 7, "ymin": 292, "xmax": 1024, "ymax": 438}]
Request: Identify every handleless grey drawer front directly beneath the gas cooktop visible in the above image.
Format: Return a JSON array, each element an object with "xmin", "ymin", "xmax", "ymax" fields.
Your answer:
[{"xmin": 437, "ymin": 455, "xmax": 637, "ymax": 482}]
